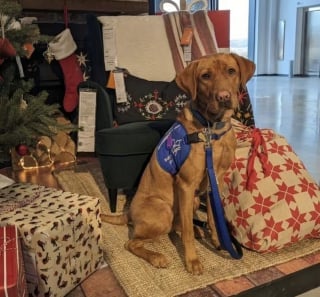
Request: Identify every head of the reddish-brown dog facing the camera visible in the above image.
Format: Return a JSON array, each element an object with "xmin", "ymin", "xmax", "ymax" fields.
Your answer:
[{"xmin": 176, "ymin": 54, "xmax": 255, "ymax": 121}]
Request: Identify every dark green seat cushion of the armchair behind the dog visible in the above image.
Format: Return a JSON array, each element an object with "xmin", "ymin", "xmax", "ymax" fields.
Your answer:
[{"xmin": 96, "ymin": 119, "xmax": 175, "ymax": 156}]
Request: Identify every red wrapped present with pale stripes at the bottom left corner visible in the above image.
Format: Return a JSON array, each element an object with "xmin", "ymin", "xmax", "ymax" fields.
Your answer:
[{"xmin": 0, "ymin": 225, "xmax": 28, "ymax": 297}]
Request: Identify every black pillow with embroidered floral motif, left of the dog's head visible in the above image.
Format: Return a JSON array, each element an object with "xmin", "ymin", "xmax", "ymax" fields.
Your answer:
[{"xmin": 115, "ymin": 73, "xmax": 189, "ymax": 125}]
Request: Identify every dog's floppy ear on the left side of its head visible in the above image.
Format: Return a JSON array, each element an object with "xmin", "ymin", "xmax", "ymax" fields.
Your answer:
[{"xmin": 176, "ymin": 61, "xmax": 198, "ymax": 100}]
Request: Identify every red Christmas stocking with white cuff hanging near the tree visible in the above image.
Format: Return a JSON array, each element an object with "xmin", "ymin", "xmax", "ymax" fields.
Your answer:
[{"xmin": 48, "ymin": 28, "xmax": 83, "ymax": 112}]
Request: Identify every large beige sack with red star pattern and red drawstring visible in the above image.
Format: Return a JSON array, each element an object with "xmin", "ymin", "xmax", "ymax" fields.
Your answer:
[{"xmin": 222, "ymin": 122, "xmax": 320, "ymax": 252}]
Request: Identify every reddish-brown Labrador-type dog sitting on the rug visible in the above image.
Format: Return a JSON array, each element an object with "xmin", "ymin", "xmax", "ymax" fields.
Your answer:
[{"xmin": 102, "ymin": 54, "xmax": 255, "ymax": 274}]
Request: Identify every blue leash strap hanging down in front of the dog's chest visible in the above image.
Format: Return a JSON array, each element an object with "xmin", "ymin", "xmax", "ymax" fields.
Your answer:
[{"xmin": 206, "ymin": 146, "xmax": 243, "ymax": 259}]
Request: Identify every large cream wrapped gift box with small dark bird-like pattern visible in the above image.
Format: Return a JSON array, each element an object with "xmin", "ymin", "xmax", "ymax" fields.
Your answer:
[{"xmin": 0, "ymin": 183, "xmax": 103, "ymax": 297}]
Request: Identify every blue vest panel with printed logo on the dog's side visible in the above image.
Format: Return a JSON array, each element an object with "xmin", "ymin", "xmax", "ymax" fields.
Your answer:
[{"xmin": 156, "ymin": 122, "xmax": 191, "ymax": 175}]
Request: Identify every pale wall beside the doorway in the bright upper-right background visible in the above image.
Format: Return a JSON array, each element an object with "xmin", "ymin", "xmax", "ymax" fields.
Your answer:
[{"xmin": 254, "ymin": 0, "xmax": 320, "ymax": 75}]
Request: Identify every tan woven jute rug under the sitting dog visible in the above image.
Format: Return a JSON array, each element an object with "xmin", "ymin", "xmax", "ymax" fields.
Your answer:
[{"xmin": 55, "ymin": 164, "xmax": 320, "ymax": 297}]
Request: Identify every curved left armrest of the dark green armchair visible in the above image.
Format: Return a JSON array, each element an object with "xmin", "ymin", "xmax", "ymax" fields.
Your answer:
[{"xmin": 78, "ymin": 80, "xmax": 114, "ymax": 131}]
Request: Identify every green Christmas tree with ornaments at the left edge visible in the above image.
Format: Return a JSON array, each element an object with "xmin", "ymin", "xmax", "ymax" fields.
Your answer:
[{"xmin": 0, "ymin": 0, "xmax": 76, "ymax": 162}]
